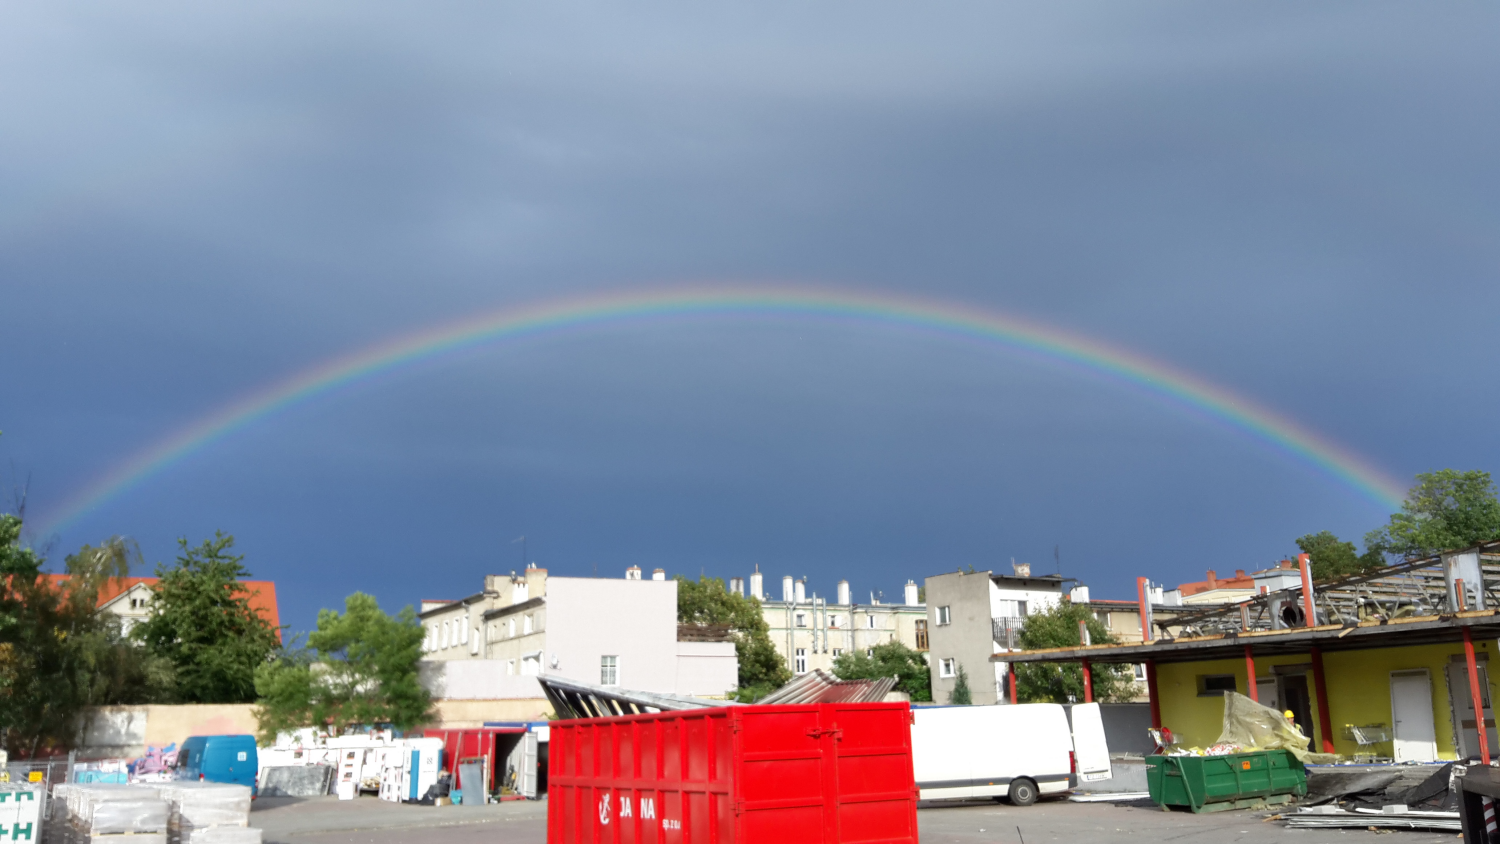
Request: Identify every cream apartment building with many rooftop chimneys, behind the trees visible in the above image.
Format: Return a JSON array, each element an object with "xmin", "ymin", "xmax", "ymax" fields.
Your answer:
[{"xmin": 729, "ymin": 567, "xmax": 927, "ymax": 675}]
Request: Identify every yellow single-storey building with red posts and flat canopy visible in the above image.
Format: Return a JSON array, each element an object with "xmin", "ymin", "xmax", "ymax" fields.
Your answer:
[{"xmin": 996, "ymin": 610, "xmax": 1500, "ymax": 762}]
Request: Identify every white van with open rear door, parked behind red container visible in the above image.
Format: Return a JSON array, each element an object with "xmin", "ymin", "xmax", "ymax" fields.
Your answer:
[{"xmin": 912, "ymin": 703, "xmax": 1110, "ymax": 807}]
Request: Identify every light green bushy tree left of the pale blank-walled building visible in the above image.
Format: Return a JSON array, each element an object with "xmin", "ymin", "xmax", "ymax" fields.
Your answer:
[{"xmin": 255, "ymin": 592, "xmax": 432, "ymax": 742}]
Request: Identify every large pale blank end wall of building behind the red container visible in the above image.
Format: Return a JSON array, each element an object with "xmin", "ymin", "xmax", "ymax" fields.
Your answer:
[{"xmin": 543, "ymin": 577, "xmax": 678, "ymax": 693}]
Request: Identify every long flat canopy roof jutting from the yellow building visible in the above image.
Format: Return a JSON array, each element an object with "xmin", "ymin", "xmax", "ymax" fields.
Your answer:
[{"xmin": 990, "ymin": 610, "xmax": 1500, "ymax": 664}]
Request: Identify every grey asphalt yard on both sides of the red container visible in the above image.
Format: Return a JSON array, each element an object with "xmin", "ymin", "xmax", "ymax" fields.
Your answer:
[{"xmin": 251, "ymin": 798, "xmax": 1458, "ymax": 844}]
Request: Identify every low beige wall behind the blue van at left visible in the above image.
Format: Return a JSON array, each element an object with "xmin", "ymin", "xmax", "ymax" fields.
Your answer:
[{"xmin": 78, "ymin": 703, "xmax": 258, "ymax": 759}]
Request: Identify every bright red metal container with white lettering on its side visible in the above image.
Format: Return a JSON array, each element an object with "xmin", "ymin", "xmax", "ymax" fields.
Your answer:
[{"xmin": 548, "ymin": 703, "xmax": 917, "ymax": 844}]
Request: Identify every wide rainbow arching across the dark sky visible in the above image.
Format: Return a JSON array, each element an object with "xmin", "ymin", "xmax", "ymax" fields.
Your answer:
[{"xmin": 32, "ymin": 288, "xmax": 1403, "ymax": 535}]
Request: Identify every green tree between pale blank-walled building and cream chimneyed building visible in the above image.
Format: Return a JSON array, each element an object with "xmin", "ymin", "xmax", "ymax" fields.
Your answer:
[{"xmin": 677, "ymin": 574, "xmax": 792, "ymax": 702}]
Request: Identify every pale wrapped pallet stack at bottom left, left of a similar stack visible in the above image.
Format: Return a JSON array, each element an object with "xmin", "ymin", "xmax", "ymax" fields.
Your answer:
[{"xmin": 48, "ymin": 783, "xmax": 168, "ymax": 844}]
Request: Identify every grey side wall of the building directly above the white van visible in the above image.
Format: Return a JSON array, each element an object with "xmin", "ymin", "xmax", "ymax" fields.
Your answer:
[{"xmin": 927, "ymin": 571, "xmax": 999, "ymax": 703}]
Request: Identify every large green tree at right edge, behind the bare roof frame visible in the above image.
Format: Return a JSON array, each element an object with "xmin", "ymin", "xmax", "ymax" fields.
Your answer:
[{"xmin": 1365, "ymin": 469, "xmax": 1500, "ymax": 559}]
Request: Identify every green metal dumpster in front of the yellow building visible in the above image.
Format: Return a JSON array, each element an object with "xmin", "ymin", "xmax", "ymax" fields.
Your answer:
[{"xmin": 1146, "ymin": 750, "xmax": 1308, "ymax": 813}]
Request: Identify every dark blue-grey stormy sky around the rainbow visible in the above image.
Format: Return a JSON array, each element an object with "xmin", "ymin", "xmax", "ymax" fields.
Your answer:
[{"xmin": 0, "ymin": 3, "xmax": 1500, "ymax": 630}]
